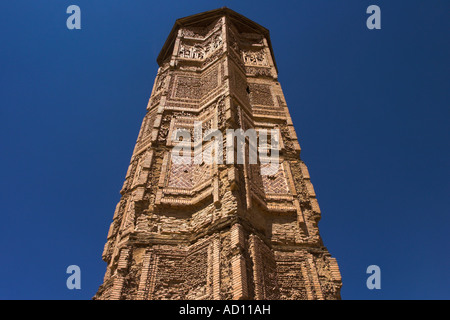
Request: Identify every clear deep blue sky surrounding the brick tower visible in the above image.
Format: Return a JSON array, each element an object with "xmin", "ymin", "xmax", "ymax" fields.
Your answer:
[{"xmin": 0, "ymin": 0, "xmax": 450, "ymax": 299}]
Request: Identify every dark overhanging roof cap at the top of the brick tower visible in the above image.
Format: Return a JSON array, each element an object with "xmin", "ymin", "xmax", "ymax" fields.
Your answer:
[{"xmin": 156, "ymin": 7, "xmax": 278, "ymax": 71}]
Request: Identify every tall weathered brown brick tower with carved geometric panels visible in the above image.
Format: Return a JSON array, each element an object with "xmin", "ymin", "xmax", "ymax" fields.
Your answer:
[{"xmin": 94, "ymin": 8, "xmax": 342, "ymax": 300}]
